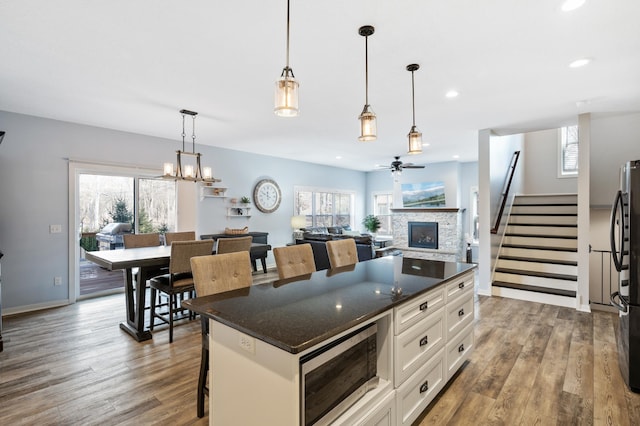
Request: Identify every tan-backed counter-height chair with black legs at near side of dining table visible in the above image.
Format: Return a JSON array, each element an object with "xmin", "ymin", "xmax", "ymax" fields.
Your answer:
[{"xmin": 149, "ymin": 240, "xmax": 213, "ymax": 343}]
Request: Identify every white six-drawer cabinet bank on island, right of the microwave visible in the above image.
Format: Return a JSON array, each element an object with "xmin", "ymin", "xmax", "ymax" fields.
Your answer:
[{"xmin": 393, "ymin": 272, "xmax": 474, "ymax": 425}]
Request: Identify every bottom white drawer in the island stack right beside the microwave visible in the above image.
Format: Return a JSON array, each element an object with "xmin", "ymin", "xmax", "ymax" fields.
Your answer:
[{"xmin": 396, "ymin": 349, "xmax": 445, "ymax": 425}]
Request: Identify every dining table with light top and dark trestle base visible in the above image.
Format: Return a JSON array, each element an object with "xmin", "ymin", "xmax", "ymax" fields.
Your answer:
[{"xmin": 85, "ymin": 243, "xmax": 271, "ymax": 342}]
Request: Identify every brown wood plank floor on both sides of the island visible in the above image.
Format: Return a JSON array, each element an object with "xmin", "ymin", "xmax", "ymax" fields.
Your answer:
[{"xmin": 0, "ymin": 272, "xmax": 640, "ymax": 426}]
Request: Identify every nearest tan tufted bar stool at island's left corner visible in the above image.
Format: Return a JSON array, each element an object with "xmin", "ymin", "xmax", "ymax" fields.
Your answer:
[{"xmin": 191, "ymin": 250, "xmax": 253, "ymax": 417}]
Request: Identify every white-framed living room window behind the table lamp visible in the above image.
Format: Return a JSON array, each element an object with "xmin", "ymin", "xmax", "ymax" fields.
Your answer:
[{"xmin": 294, "ymin": 187, "xmax": 355, "ymax": 228}]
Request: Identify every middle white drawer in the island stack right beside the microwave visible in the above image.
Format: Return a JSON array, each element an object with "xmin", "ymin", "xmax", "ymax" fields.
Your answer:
[{"xmin": 393, "ymin": 308, "xmax": 445, "ymax": 387}]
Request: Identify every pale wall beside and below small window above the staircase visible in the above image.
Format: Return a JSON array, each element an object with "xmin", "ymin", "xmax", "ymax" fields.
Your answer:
[{"xmin": 520, "ymin": 129, "xmax": 578, "ymax": 195}]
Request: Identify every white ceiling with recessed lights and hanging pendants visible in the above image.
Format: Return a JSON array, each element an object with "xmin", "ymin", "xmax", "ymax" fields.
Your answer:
[{"xmin": 0, "ymin": 0, "xmax": 640, "ymax": 170}]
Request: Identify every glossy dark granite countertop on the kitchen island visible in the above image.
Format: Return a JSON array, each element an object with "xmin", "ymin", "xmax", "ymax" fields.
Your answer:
[{"xmin": 182, "ymin": 256, "xmax": 476, "ymax": 353}]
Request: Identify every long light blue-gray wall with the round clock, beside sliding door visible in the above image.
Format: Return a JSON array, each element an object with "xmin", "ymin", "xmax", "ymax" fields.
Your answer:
[{"xmin": 0, "ymin": 111, "xmax": 366, "ymax": 313}]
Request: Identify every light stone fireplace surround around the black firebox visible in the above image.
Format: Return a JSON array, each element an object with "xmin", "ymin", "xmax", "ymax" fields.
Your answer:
[{"xmin": 391, "ymin": 207, "xmax": 465, "ymax": 262}]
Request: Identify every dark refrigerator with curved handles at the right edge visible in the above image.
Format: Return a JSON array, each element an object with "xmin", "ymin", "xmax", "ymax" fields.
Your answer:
[{"xmin": 611, "ymin": 160, "xmax": 640, "ymax": 392}]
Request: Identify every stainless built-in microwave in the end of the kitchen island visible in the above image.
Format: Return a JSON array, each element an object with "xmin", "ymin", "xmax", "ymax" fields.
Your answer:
[{"xmin": 300, "ymin": 323, "xmax": 379, "ymax": 426}]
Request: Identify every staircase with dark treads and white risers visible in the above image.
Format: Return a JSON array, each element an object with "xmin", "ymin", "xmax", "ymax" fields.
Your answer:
[{"xmin": 492, "ymin": 194, "xmax": 578, "ymax": 308}]
